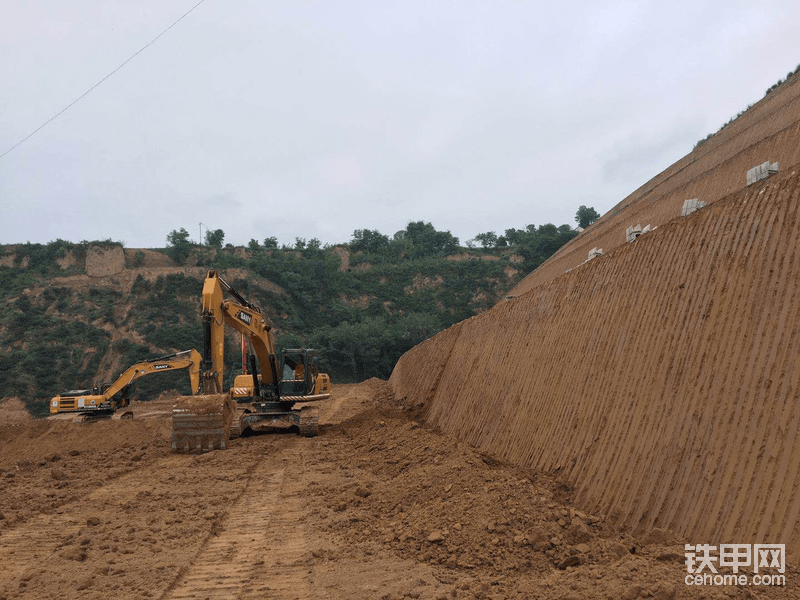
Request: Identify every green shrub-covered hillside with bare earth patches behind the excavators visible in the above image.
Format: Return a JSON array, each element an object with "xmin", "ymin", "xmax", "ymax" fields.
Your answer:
[{"xmin": 0, "ymin": 222, "xmax": 576, "ymax": 416}]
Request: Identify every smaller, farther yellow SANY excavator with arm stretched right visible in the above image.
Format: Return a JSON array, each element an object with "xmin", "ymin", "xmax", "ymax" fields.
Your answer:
[{"xmin": 50, "ymin": 349, "xmax": 203, "ymax": 421}]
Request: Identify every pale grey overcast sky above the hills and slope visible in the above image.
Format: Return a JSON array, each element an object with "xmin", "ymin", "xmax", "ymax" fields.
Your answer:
[{"xmin": 0, "ymin": 0, "xmax": 800, "ymax": 247}]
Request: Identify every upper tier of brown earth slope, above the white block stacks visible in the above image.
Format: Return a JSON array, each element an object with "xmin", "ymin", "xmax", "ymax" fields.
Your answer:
[{"xmin": 510, "ymin": 75, "xmax": 800, "ymax": 295}]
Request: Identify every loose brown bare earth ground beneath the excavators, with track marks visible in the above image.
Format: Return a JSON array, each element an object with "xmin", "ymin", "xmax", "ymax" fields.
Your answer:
[{"xmin": 0, "ymin": 386, "xmax": 800, "ymax": 600}]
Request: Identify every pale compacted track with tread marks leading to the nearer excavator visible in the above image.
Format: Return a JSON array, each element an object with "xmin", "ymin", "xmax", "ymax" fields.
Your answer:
[{"xmin": 163, "ymin": 437, "xmax": 311, "ymax": 600}]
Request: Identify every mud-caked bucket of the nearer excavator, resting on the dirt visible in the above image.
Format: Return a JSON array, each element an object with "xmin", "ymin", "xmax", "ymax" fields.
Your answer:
[{"xmin": 172, "ymin": 394, "xmax": 236, "ymax": 453}]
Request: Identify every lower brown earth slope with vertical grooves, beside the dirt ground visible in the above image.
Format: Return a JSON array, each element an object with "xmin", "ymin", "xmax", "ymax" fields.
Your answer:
[{"xmin": 390, "ymin": 170, "xmax": 800, "ymax": 558}]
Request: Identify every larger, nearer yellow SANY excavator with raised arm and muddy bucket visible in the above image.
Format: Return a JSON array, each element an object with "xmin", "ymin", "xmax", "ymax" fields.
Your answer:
[{"xmin": 172, "ymin": 271, "xmax": 331, "ymax": 452}]
